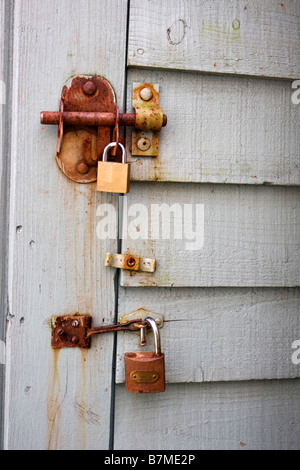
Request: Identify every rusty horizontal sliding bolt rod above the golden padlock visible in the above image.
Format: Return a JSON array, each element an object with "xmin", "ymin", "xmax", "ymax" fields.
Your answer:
[{"xmin": 41, "ymin": 111, "xmax": 167, "ymax": 127}]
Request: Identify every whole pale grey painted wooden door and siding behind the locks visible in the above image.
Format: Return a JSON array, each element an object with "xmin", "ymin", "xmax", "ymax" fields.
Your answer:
[{"xmin": 0, "ymin": 0, "xmax": 300, "ymax": 450}]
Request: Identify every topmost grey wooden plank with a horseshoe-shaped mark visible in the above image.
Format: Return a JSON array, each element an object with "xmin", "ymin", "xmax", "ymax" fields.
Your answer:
[{"xmin": 128, "ymin": 0, "xmax": 300, "ymax": 78}]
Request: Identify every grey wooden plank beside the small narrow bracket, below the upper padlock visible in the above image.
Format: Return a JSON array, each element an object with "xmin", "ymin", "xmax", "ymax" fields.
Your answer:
[{"xmin": 122, "ymin": 183, "xmax": 300, "ymax": 287}]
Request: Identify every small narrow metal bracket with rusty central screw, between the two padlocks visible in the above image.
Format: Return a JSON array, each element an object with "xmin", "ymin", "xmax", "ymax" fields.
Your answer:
[{"xmin": 105, "ymin": 253, "xmax": 156, "ymax": 273}]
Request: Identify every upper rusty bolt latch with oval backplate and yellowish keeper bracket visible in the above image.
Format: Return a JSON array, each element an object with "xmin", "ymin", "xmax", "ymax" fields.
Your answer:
[{"xmin": 41, "ymin": 76, "xmax": 167, "ymax": 183}]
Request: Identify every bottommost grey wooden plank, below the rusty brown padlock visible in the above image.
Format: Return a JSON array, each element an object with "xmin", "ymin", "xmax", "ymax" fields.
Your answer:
[{"xmin": 115, "ymin": 380, "xmax": 300, "ymax": 451}]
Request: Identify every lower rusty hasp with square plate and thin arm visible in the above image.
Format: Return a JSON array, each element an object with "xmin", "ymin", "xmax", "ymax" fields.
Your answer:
[{"xmin": 51, "ymin": 314, "xmax": 146, "ymax": 349}]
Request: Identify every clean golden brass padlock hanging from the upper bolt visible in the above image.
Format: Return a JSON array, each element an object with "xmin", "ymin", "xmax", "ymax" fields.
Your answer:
[{"xmin": 97, "ymin": 142, "xmax": 130, "ymax": 194}]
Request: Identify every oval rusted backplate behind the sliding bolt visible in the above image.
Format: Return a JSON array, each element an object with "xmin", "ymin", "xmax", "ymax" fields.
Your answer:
[{"xmin": 56, "ymin": 76, "xmax": 116, "ymax": 183}]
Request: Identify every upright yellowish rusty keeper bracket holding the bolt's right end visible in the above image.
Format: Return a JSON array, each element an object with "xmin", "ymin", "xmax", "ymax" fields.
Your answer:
[{"xmin": 132, "ymin": 83, "xmax": 164, "ymax": 157}]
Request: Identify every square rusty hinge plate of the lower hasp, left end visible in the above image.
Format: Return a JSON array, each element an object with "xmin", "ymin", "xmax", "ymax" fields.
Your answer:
[{"xmin": 51, "ymin": 315, "xmax": 92, "ymax": 349}]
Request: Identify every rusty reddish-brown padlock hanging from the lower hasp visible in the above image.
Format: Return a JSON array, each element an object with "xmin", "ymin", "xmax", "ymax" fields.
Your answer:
[{"xmin": 125, "ymin": 317, "xmax": 165, "ymax": 393}]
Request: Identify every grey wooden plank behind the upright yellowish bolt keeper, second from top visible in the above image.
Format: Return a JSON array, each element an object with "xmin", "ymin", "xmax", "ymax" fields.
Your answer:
[{"xmin": 127, "ymin": 69, "xmax": 300, "ymax": 185}]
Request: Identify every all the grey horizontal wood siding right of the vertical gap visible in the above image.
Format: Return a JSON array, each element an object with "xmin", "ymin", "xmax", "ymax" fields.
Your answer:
[{"xmin": 115, "ymin": 0, "xmax": 300, "ymax": 451}]
